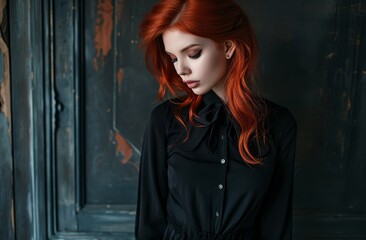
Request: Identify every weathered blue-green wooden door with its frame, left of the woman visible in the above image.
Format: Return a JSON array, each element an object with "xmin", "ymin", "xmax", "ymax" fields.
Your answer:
[{"xmin": 10, "ymin": 0, "xmax": 156, "ymax": 239}]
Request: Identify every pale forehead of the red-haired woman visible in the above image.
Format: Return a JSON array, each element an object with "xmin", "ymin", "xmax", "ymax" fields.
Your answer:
[{"xmin": 162, "ymin": 29, "xmax": 215, "ymax": 53}]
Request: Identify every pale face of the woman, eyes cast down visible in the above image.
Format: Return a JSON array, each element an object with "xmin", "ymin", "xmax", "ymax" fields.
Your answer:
[{"xmin": 162, "ymin": 29, "xmax": 227, "ymax": 98}]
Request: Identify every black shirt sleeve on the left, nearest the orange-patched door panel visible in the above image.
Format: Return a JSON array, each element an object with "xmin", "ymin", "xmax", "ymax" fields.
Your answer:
[{"xmin": 135, "ymin": 105, "xmax": 168, "ymax": 240}]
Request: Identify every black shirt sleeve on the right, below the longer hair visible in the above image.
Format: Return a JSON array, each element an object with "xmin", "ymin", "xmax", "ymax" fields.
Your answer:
[{"xmin": 258, "ymin": 111, "xmax": 297, "ymax": 240}]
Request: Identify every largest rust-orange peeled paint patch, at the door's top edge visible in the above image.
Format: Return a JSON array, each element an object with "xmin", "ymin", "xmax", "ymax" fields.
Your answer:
[{"xmin": 93, "ymin": 0, "xmax": 113, "ymax": 70}]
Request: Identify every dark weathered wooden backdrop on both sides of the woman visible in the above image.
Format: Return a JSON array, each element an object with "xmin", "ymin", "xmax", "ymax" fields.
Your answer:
[{"xmin": 0, "ymin": 0, "xmax": 366, "ymax": 240}]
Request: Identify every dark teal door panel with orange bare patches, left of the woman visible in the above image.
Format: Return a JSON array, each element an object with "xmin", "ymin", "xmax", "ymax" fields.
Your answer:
[{"xmin": 50, "ymin": 1, "xmax": 156, "ymax": 238}]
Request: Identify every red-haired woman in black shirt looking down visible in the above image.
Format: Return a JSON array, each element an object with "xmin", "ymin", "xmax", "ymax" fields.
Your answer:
[{"xmin": 135, "ymin": 0, "xmax": 296, "ymax": 240}]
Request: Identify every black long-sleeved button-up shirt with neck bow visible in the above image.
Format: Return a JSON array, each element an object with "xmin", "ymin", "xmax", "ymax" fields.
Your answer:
[{"xmin": 135, "ymin": 91, "xmax": 296, "ymax": 240}]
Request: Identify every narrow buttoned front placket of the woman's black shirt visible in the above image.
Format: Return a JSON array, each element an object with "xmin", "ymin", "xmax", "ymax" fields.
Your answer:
[{"xmin": 215, "ymin": 123, "xmax": 228, "ymax": 233}]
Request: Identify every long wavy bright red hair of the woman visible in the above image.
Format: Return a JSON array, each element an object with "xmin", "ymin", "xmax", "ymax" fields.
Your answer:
[{"xmin": 140, "ymin": 0, "xmax": 266, "ymax": 164}]
